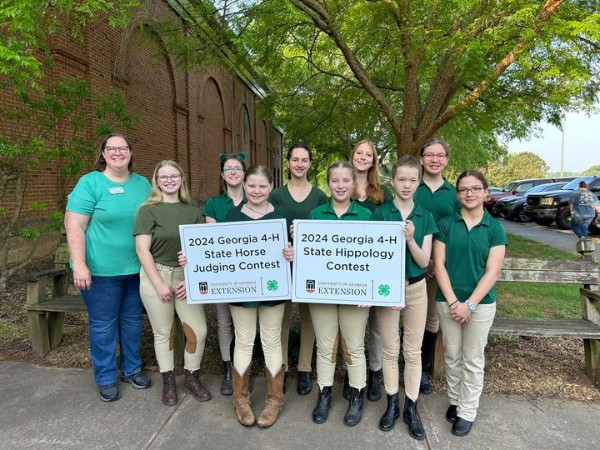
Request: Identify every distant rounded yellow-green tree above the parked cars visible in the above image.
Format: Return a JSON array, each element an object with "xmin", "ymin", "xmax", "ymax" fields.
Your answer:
[{"xmin": 486, "ymin": 152, "xmax": 550, "ymax": 186}]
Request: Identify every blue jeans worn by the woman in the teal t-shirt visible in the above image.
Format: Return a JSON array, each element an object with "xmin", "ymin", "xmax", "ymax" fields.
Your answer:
[{"xmin": 81, "ymin": 273, "xmax": 143, "ymax": 386}]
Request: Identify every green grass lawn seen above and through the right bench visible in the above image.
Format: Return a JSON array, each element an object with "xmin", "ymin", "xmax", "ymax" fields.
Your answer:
[{"xmin": 496, "ymin": 233, "xmax": 592, "ymax": 319}]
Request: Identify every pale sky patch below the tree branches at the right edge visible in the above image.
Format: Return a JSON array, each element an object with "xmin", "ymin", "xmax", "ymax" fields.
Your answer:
[{"xmin": 506, "ymin": 113, "xmax": 600, "ymax": 173}]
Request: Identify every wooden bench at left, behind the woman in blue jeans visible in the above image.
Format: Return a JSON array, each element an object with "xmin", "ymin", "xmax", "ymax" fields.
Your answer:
[{"xmin": 25, "ymin": 267, "xmax": 184, "ymax": 368}]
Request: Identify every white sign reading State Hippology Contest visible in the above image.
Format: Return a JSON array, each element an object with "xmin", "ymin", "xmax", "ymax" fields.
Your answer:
[{"xmin": 292, "ymin": 220, "xmax": 406, "ymax": 306}]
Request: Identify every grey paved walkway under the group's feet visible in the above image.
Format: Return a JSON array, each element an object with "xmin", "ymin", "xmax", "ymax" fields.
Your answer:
[{"xmin": 0, "ymin": 362, "xmax": 600, "ymax": 450}]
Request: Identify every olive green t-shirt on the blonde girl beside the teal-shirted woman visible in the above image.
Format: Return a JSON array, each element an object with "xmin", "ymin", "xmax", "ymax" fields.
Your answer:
[{"xmin": 133, "ymin": 202, "xmax": 201, "ymax": 267}]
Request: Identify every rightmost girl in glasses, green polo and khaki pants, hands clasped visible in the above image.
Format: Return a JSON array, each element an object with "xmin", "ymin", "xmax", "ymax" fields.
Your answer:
[{"xmin": 433, "ymin": 170, "xmax": 507, "ymax": 436}]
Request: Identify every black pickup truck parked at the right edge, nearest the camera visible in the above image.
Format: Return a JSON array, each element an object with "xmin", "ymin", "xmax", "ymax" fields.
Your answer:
[{"xmin": 525, "ymin": 175, "xmax": 600, "ymax": 234}]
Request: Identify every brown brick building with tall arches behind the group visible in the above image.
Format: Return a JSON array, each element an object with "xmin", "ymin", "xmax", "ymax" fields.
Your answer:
[{"xmin": 0, "ymin": 0, "xmax": 283, "ymax": 215}]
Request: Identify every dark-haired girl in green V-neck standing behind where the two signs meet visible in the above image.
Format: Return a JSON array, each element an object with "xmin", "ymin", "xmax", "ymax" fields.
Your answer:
[{"xmin": 270, "ymin": 144, "xmax": 327, "ymax": 395}]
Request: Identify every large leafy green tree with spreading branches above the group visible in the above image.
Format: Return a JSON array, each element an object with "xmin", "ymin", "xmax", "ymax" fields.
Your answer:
[{"xmin": 193, "ymin": 0, "xmax": 600, "ymax": 167}]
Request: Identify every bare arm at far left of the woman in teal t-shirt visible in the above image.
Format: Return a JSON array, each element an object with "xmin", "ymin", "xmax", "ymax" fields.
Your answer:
[{"xmin": 65, "ymin": 211, "xmax": 92, "ymax": 290}]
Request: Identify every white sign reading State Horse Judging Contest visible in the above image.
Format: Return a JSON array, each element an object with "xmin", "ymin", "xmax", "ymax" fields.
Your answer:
[{"xmin": 179, "ymin": 219, "xmax": 292, "ymax": 303}]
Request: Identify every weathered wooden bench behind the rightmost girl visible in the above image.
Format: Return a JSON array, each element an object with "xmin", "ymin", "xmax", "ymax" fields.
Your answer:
[{"xmin": 434, "ymin": 258, "xmax": 600, "ymax": 383}]
